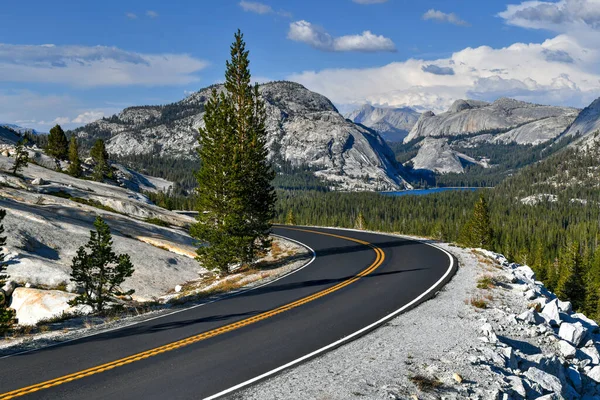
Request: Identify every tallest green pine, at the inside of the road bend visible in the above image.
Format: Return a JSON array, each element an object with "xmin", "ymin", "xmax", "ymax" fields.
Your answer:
[{"xmin": 190, "ymin": 31, "xmax": 276, "ymax": 273}]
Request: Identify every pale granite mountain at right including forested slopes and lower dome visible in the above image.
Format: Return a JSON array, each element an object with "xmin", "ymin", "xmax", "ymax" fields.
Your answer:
[{"xmin": 395, "ymin": 98, "xmax": 579, "ymax": 180}]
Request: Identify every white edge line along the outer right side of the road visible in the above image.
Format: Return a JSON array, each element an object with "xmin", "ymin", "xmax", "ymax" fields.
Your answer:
[{"xmin": 204, "ymin": 228, "xmax": 454, "ymax": 400}]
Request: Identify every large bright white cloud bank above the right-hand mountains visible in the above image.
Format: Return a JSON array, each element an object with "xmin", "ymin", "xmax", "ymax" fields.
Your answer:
[{"xmin": 289, "ymin": 35, "xmax": 600, "ymax": 112}]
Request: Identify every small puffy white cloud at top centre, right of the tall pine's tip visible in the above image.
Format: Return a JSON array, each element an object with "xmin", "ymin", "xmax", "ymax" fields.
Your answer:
[{"xmin": 288, "ymin": 21, "xmax": 396, "ymax": 52}]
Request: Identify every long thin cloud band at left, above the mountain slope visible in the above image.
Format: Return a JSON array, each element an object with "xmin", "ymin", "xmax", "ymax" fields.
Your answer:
[{"xmin": 0, "ymin": 44, "xmax": 207, "ymax": 87}]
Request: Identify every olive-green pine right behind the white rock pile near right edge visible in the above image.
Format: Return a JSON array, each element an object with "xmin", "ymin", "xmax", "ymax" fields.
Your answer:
[{"xmin": 556, "ymin": 242, "xmax": 585, "ymax": 310}]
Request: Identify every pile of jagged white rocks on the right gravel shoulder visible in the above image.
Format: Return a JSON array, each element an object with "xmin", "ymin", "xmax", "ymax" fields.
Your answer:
[{"xmin": 470, "ymin": 250, "xmax": 600, "ymax": 400}]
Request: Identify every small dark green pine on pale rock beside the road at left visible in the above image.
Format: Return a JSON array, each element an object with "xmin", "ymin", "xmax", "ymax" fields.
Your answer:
[{"xmin": 69, "ymin": 217, "xmax": 134, "ymax": 311}]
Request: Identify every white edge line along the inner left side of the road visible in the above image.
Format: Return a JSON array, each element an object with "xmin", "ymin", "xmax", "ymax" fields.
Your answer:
[{"xmin": 0, "ymin": 234, "xmax": 317, "ymax": 360}]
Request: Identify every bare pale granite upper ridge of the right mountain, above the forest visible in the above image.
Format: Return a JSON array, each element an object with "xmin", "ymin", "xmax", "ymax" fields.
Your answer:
[{"xmin": 404, "ymin": 98, "xmax": 579, "ymax": 144}]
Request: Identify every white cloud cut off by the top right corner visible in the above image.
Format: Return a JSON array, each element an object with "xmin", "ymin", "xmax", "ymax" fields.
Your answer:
[{"xmin": 498, "ymin": 0, "xmax": 600, "ymax": 32}]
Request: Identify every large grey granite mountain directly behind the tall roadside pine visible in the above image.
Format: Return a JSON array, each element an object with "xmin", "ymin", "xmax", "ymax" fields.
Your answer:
[{"xmin": 74, "ymin": 82, "xmax": 410, "ymax": 190}]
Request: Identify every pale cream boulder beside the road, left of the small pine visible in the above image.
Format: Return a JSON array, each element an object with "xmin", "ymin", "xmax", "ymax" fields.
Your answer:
[{"xmin": 10, "ymin": 288, "xmax": 92, "ymax": 325}]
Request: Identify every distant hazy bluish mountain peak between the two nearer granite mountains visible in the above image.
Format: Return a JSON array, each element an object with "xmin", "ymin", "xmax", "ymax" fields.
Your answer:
[{"xmin": 346, "ymin": 104, "xmax": 420, "ymax": 142}]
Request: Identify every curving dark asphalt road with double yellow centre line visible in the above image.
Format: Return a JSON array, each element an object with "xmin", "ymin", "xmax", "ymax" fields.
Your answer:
[{"xmin": 0, "ymin": 226, "xmax": 457, "ymax": 400}]
